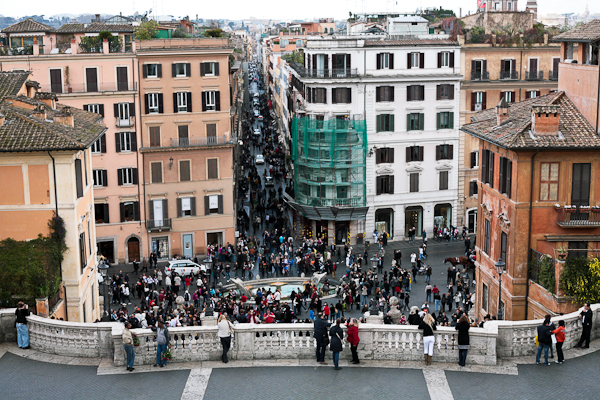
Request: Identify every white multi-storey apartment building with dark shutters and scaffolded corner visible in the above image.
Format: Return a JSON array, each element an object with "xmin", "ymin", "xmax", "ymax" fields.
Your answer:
[{"xmin": 290, "ymin": 35, "xmax": 461, "ymax": 242}]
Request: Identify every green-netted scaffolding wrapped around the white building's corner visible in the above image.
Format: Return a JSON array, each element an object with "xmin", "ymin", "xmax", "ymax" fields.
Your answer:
[{"xmin": 287, "ymin": 116, "xmax": 368, "ymax": 242}]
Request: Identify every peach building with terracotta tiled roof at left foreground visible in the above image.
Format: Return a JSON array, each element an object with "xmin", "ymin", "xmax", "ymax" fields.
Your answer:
[{"xmin": 0, "ymin": 72, "xmax": 106, "ymax": 322}]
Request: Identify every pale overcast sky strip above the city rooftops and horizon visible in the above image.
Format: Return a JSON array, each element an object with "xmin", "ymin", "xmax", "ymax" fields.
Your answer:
[{"xmin": 0, "ymin": 0, "xmax": 600, "ymax": 20}]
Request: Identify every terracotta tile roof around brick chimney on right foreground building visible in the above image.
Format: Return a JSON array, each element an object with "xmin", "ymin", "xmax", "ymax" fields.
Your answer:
[{"xmin": 461, "ymin": 92, "xmax": 600, "ymax": 149}]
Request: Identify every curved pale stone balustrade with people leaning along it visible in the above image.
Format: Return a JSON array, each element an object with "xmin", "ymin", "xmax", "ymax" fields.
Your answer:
[{"xmin": 0, "ymin": 304, "xmax": 600, "ymax": 365}]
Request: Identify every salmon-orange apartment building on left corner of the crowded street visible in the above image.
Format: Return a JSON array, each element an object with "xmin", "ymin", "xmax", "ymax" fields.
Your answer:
[{"xmin": 137, "ymin": 39, "xmax": 235, "ymax": 258}]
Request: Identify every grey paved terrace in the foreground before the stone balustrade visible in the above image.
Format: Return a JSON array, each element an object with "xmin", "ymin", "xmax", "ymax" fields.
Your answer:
[{"xmin": 0, "ymin": 340, "xmax": 600, "ymax": 400}]
